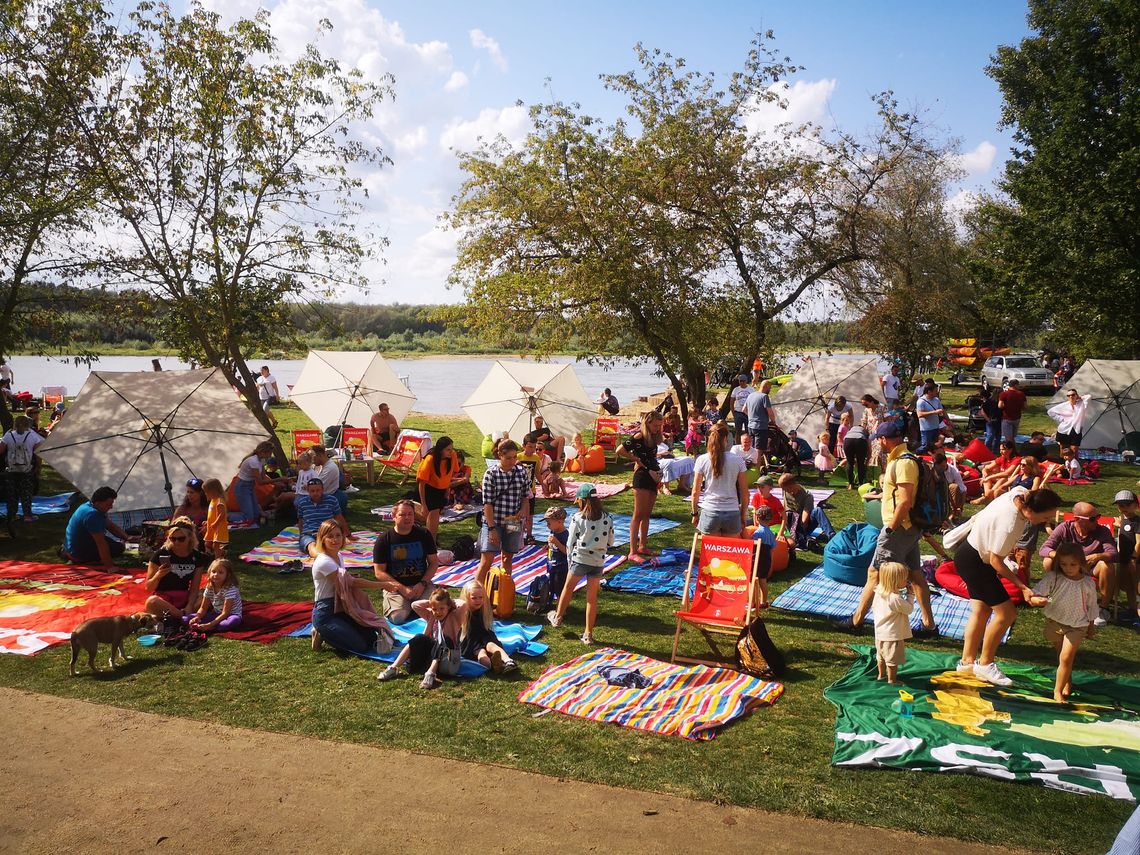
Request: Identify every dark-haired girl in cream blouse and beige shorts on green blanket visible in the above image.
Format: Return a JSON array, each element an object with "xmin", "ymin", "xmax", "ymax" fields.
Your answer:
[{"xmin": 1029, "ymin": 544, "xmax": 1100, "ymax": 703}]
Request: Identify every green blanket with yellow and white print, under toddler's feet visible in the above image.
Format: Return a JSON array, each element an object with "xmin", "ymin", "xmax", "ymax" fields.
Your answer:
[{"xmin": 823, "ymin": 645, "xmax": 1140, "ymax": 799}]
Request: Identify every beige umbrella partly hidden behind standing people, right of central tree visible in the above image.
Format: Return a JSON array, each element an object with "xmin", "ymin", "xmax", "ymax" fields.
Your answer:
[{"xmin": 772, "ymin": 357, "xmax": 882, "ymax": 448}]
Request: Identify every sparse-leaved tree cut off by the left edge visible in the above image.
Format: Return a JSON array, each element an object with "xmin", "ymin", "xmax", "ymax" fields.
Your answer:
[{"xmin": 0, "ymin": 0, "xmax": 112, "ymax": 353}]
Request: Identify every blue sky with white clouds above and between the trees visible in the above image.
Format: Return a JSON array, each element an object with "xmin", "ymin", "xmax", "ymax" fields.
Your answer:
[{"xmin": 189, "ymin": 0, "xmax": 1028, "ymax": 303}]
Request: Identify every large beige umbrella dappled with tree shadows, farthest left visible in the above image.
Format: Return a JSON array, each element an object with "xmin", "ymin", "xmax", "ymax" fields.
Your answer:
[{"xmin": 36, "ymin": 368, "xmax": 269, "ymax": 511}]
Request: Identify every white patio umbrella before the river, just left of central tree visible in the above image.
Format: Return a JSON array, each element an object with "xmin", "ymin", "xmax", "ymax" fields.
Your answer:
[{"xmin": 463, "ymin": 361, "xmax": 597, "ymax": 439}]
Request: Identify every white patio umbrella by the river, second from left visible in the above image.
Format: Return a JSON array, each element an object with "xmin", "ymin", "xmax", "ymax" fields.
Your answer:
[{"xmin": 290, "ymin": 350, "xmax": 416, "ymax": 442}]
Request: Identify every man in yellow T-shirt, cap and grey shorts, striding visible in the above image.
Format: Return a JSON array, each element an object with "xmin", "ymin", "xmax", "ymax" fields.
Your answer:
[{"xmin": 837, "ymin": 420, "xmax": 938, "ymax": 638}]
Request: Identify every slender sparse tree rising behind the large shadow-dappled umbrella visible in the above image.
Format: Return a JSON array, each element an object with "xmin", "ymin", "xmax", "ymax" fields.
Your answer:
[{"xmin": 80, "ymin": 2, "xmax": 391, "ymax": 449}]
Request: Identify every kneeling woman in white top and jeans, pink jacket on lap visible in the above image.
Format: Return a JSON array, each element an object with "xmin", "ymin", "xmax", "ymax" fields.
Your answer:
[{"xmin": 312, "ymin": 520, "xmax": 392, "ymax": 653}]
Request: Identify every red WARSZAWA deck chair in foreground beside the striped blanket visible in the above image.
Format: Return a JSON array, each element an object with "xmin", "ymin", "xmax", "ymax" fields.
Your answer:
[{"xmin": 669, "ymin": 531, "xmax": 760, "ymax": 667}]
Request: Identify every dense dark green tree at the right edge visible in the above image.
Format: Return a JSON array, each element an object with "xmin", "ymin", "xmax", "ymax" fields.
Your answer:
[{"xmin": 977, "ymin": 0, "xmax": 1140, "ymax": 358}]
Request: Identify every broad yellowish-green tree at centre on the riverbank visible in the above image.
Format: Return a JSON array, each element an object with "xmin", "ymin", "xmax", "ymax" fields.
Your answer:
[{"xmin": 450, "ymin": 33, "xmax": 939, "ymax": 419}]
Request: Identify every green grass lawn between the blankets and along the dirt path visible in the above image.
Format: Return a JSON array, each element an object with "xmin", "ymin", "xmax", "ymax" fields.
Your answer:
[{"xmin": 0, "ymin": 378, "xmax": 1140, "ymax": 853}]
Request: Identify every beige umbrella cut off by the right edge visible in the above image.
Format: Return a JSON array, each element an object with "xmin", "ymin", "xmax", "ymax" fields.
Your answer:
[{"xmin": 1048, "ymin": 359, "xmax": 1140, "ymax": 451}]
